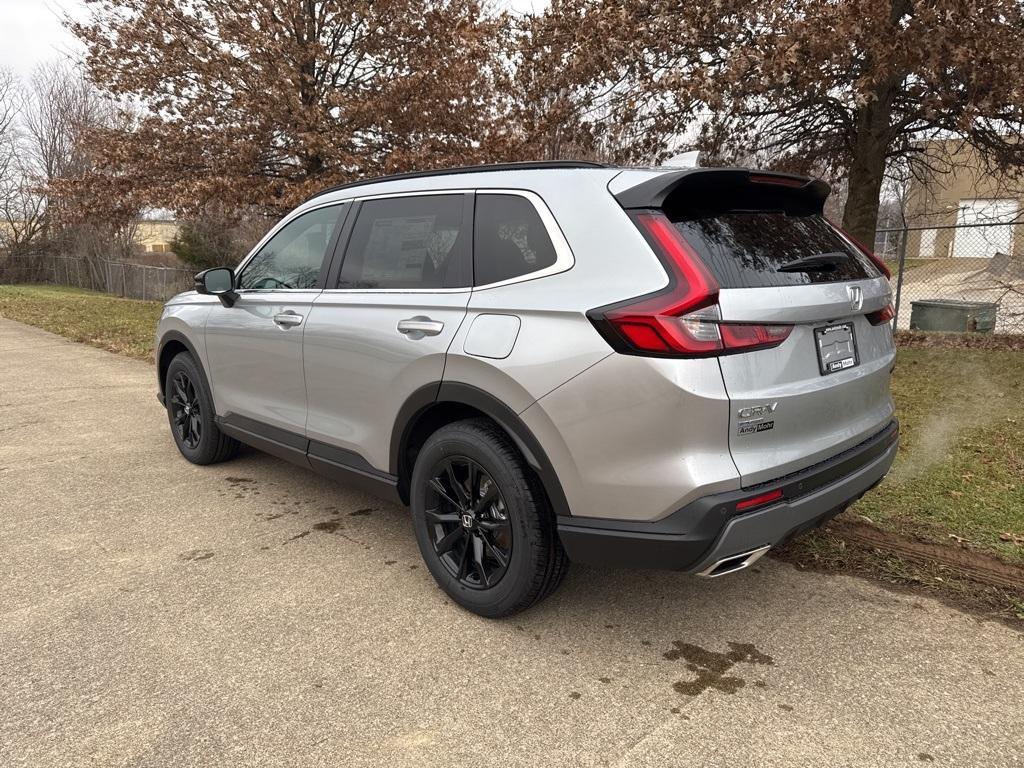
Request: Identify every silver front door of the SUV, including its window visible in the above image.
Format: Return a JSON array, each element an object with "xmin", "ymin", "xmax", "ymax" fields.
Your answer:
[{"xmin": 206, "ymin": 205, "xmax": 344, "ymax": 435}]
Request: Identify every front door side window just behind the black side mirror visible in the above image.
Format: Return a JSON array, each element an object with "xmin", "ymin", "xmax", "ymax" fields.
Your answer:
[{"xmin": 239, "ymin": 205, "xmax": 343, "ymax": 290}]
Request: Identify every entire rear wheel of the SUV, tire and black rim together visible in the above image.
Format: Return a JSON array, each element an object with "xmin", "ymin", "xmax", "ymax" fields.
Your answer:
[{"xmin": 410, "ymin": 419, "xmax": 568, "ymax": 618}]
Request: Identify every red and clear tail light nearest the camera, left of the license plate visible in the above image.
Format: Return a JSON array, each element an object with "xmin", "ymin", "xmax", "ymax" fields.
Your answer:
[{"xmin": 587, "ymin": 213, "xmax": 793, "ymax": 357}]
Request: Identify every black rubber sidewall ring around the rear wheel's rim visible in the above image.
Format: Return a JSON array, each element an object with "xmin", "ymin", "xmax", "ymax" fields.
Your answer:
[{"xmin": 410, "ymin": 425, "xmax": 538, "ymax": 615}]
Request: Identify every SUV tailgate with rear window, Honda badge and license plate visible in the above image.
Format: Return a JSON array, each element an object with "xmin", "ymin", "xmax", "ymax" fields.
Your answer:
[{"xmin": 670, "ymin": 202, "xmax": 895, "ymax": 485}]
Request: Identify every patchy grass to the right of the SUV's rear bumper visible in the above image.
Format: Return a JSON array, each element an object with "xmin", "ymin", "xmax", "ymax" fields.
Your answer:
[{"xmin": 848, "ymin": 348, "xmax": 1024, "ymax": 565}]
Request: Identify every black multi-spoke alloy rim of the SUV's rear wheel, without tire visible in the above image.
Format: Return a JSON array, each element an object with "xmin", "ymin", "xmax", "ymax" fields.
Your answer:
[{"xmin": 425, "ymin": 456, "xmax": 512, "ymax": 589}]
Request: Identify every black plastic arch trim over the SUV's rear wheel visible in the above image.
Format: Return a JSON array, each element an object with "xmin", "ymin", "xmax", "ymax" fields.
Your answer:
[{"xmin": 389, "ymin": 381, "xmax": 571, "ymax": 516}]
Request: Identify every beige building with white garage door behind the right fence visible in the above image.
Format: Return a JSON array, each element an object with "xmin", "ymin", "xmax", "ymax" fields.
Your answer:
[{"xmin": 906, "ymin": 141, "xmax": 1024, "ymax": 259}]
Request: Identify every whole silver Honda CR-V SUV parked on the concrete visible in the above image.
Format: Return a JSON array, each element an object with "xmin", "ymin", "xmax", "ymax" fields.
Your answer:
[{"xmin": 157, "ymin": 163, "xmax": 897, "ymax": 616}]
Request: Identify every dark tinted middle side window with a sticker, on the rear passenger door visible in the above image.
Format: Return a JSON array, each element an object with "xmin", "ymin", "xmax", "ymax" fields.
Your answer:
[{"xmin": 338, "ymin": 195, "xmax": 470, "ymax": 289}]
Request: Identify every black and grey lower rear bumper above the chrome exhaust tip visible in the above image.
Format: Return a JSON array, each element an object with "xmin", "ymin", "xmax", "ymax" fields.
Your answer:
[{"xmin": 558, "ymin": 421, "xmax": 899, "ymax": 573}]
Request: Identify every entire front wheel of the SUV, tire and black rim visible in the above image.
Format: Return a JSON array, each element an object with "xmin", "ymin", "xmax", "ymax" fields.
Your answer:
[{"xmin": 164, "ymin": 352, "xmax": 239, "ymax": 465}]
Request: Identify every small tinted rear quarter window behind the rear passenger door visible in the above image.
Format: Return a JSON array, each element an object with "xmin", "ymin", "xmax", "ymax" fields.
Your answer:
[{"xmin": 473, "ymin": 195, "xmax": 557, "ymax": 286}]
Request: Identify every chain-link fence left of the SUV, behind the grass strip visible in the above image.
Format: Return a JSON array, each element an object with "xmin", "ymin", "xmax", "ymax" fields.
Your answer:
[{"xmin": 0, "ymin": 255, "xmax": 195, "ymax": 301}]
